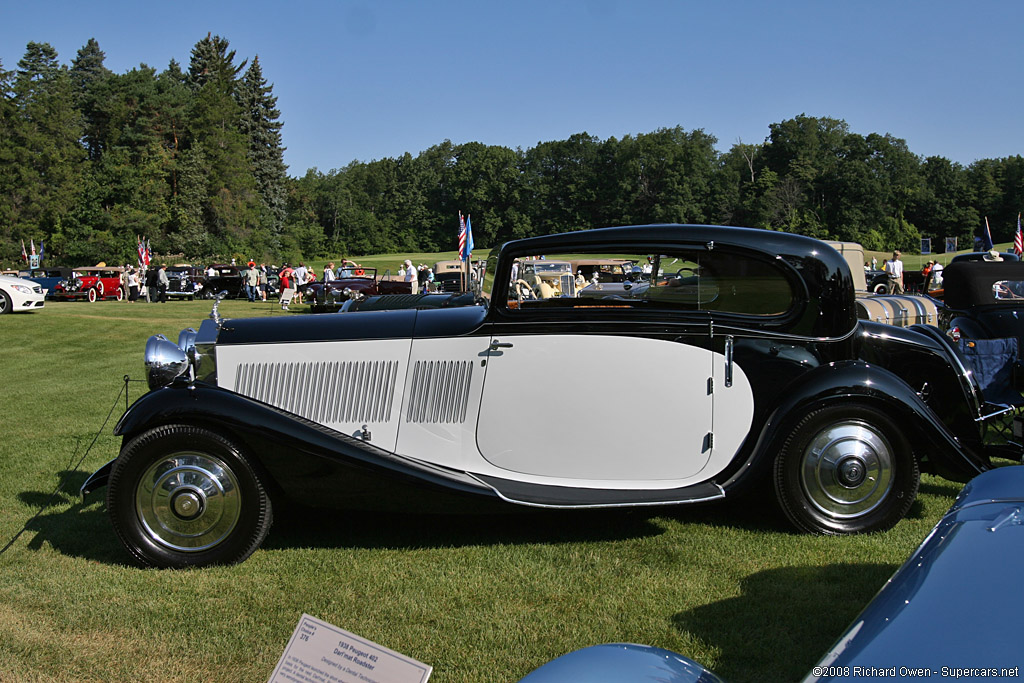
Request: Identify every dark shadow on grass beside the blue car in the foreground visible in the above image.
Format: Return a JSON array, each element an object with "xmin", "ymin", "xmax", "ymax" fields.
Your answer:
[{"xmin": 672, "ymin": 564, "xmax": 897, "ymax": 682}]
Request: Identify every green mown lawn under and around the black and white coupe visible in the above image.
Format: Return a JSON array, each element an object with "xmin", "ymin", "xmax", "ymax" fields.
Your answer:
[{"xmin": 0, "ymin": 296, "xmax": 959, "ymax": 683}]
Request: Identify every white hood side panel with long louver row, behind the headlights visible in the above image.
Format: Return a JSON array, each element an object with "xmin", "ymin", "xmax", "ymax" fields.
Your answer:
[{"xmin": 217, "ymin": 339, "xmax": 412, "ymax": 451}]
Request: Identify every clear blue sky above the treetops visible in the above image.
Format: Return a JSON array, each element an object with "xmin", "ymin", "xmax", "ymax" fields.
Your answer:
[{"xmin": 0, "ymin": 0, "xmax": 1024, "ymax": 175}]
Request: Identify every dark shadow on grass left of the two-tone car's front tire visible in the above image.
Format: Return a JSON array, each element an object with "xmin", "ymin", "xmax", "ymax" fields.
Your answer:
[{"xmin": 18, "ymin": 470, "xmax": 129, "ymax": 564}]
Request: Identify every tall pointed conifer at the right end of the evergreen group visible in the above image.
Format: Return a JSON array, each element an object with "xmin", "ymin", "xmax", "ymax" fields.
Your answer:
[{"xmin": 238, "ymin": 55, "xmax": 288, "ymax": 234}]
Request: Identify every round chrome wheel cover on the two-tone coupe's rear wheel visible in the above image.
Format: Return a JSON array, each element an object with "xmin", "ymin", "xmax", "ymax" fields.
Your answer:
[{"xmin": 800, "ymin": 421, "xmax": 894, "ymax": 519}]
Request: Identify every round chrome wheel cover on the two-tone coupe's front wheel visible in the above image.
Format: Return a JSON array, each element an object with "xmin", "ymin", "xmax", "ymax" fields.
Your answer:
[{"xmin": 135, "ymin": 452, "xmax": 242, "ymax": 553}]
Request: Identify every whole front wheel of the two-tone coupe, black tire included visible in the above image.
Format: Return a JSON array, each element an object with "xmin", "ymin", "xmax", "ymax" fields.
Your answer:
[{"xmin": 106, "ymin": 425, "xmax": 273, "ymax": 568}]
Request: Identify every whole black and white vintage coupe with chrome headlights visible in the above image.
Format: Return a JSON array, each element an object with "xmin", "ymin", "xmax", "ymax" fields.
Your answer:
[{"xmin": 83, "ymin": 225, "xmax": 1015, "ymax": 567}]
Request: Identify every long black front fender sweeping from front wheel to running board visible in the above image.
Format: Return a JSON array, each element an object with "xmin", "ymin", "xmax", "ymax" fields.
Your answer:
[{"xmin": 115, "ymin": 384, "xmax": 510, "ymax": 512}]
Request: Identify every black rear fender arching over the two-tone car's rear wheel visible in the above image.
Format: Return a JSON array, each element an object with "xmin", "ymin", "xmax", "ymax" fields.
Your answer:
[{"xmin": 757, "ymin": 360, "xmax": 991, "ymax": 488}]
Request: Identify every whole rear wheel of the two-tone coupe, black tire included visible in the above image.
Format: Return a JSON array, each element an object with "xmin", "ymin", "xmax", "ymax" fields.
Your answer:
[{"xmin": 774, "ymin": 404, "xmax": 921, "ymax": 535}]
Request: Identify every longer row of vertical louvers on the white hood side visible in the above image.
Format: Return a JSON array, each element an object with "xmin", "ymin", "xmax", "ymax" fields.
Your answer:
[{"xmin": 234, "ymin": 360, "xmax": 398, "ymax": 424}]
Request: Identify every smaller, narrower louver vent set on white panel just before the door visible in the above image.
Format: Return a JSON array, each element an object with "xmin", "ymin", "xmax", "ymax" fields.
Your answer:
[{"xmin": 406, "ymin": 360, "xmax": 473, "ymax": 423}]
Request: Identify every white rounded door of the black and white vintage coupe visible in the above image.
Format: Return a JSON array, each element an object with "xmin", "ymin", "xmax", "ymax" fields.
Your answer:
[{"xmin": 477, "ymin": 335, "xmax": 712, "ymax": 486}]
